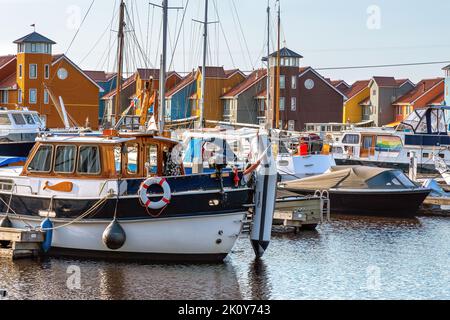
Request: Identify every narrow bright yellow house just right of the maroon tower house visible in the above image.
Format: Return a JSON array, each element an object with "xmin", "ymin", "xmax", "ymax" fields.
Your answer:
[{"xmin": 342, "ymin": 80, "xmax": 370, "ymax": 123}]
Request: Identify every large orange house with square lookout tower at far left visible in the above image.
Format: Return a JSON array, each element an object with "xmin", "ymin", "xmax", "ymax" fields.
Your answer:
[{"xmin": 0, "ymin": 32, "xmax": 103, "ymax": 129}]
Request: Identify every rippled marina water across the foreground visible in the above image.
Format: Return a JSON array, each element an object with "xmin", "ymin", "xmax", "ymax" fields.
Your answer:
[{"xmin": 0, "ymin": 216, "xmax": 450, "ymax": 300}]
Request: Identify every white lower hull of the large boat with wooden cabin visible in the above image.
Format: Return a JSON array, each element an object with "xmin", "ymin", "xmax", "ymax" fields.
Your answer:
[{"xmin": 3, "ymin": 212, "xmax": 246, "ymax": 261}]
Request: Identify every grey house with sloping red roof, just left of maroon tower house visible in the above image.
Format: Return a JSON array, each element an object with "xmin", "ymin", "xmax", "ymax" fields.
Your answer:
[{"xmin": 221, "ymin": 69, "xmax": 267, "ymax": 124}]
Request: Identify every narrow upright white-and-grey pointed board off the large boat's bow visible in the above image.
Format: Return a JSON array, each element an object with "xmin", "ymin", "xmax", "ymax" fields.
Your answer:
[{"xmin": 250, "ymin": 132, "xmax": 277, "ymax": 258}]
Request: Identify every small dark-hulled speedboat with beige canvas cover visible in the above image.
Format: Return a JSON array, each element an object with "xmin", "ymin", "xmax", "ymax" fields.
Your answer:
[{"xmin": 280, "ymin": 166, "xmax": 431, "ymax": 217}]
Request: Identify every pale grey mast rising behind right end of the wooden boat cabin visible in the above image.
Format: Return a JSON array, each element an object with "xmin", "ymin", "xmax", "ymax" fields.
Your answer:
[{"xmin": 158, "ymin": 0, "xmax": 169, "ymax": 134}]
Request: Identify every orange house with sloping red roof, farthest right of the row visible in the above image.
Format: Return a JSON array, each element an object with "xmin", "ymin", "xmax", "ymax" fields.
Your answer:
[{"xmin": 392, "ymin": 78, "xmax": 445, "ymax": 122}]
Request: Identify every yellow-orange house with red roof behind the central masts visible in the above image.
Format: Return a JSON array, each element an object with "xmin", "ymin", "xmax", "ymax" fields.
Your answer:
[{"xmin": 191, "ymin": 67, "xmax": 246, "ymax": 121}]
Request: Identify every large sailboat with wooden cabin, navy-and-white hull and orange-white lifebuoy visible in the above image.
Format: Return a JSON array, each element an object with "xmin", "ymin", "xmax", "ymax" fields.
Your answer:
[{"xmin": 0, "ymin": 0, "xmax": 276, "ymax": 262}]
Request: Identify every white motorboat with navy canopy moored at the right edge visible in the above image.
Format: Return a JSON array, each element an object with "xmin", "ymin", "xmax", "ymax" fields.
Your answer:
[{"xmin": 332, "ymin": 106, "xmax": 450, "ymax": 173}]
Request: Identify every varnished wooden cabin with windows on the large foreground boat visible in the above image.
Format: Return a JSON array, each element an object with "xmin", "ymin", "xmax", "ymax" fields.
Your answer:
[{"xmin": 21, "ymin": 133, "xmax": 184, "ymax": 179}]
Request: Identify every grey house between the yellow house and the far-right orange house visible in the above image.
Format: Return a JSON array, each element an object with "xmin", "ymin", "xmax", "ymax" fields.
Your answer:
[{"xmin": 361, "ymin": 77, "xmax": 415, "ymax": 127}]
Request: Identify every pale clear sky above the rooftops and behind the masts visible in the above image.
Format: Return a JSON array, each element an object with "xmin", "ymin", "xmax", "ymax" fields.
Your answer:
[{"xmin": 0, "ymin": 0, "xmax": 450, "ymax": 82}]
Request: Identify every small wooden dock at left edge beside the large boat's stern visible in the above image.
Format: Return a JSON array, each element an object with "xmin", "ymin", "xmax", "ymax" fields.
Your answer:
[{"xmin": 0, "ymin": 228, "xmax": 45, "ymax": 260}]
